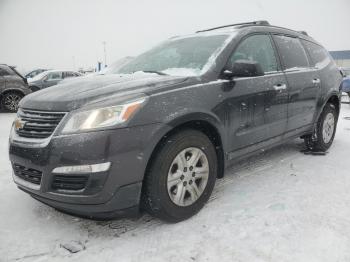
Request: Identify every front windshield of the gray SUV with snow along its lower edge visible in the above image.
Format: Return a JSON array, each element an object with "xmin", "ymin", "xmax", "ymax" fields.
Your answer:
[{"xmin": 115, "ymin": 35, "xmax": 228, "ymax": 75}]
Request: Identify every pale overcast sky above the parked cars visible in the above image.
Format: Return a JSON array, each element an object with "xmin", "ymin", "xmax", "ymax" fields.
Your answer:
[{"xmin": 0, "ymin": 0, "xmax": 350, "ymax": 70}]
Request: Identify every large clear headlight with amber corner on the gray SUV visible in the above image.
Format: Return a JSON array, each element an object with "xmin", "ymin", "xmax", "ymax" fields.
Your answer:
[{"xmin": 62, "ymin": 98, "xmax": 145, "ymax": 134}]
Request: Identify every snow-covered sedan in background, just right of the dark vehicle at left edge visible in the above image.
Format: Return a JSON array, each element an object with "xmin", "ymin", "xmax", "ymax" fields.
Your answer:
[{"xmin": 28, "ymin": 70, "xmax": 82, "ymax": 92}]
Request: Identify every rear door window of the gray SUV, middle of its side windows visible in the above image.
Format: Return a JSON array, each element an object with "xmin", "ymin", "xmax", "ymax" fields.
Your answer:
[{"xmin": 273, "ymin": 35, "xmax": 309, "ymax": 70}]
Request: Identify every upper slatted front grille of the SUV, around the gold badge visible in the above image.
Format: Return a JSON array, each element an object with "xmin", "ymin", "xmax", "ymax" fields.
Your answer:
[{"xmin": 16, "ymin": 109, "xmax": 65, "ymax": 138}]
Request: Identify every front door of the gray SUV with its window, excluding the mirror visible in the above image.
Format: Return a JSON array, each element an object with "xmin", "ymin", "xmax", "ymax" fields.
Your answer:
[{"xmin": 228, "ymin": 33, "xmax": 288, "ymax": 157}]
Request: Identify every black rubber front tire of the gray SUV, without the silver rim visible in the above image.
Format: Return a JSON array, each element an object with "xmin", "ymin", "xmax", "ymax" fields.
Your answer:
[{"xmin": 144, "ymin": 130, "xmax": 218, "ymax": 222}]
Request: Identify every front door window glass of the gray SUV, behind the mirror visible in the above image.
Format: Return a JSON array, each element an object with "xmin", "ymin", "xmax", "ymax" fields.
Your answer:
[{"xmin": 229, "ymin": 35, "xmax": 278, "ymax": 73}]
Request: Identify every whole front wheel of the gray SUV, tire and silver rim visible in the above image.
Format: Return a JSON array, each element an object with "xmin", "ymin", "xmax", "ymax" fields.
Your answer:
[{"xmin": 141, "ymin": 129, "xmax": 218, "ymax": 223}]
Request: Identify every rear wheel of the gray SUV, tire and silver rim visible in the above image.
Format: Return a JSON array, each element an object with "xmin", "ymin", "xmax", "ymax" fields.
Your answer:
[{"xmin": 304, "ymin": 103, "xmax": 338, "ymax": 152}]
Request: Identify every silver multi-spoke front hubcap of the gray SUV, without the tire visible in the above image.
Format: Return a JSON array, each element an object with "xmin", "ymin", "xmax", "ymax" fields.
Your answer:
[{"xmin": 167, "ymin": 147, "xmax": 209, "ymax": 206}]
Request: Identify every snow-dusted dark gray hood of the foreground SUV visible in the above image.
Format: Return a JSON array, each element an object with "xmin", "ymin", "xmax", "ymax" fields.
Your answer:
[{"xmin": 20, "ymin": 73, "xmax": 188, "ymax": 112}]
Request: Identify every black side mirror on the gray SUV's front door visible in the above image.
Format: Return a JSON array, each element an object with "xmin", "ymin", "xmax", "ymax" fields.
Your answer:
[{"xmin": 223, "ymin": 60, "xmax": 264, "ymax": 78}]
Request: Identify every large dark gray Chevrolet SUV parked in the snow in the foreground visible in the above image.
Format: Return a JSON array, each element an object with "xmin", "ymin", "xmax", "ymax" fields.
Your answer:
[{"xmin": 9, "ymin": 21, "xmax": 342, "ymax": 222}]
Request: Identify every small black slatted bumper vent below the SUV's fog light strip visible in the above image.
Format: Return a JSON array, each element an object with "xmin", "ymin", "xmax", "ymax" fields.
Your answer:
[{"xmin": 52, "ymin": 175, "xmax": 88, "ymax": 190}]
